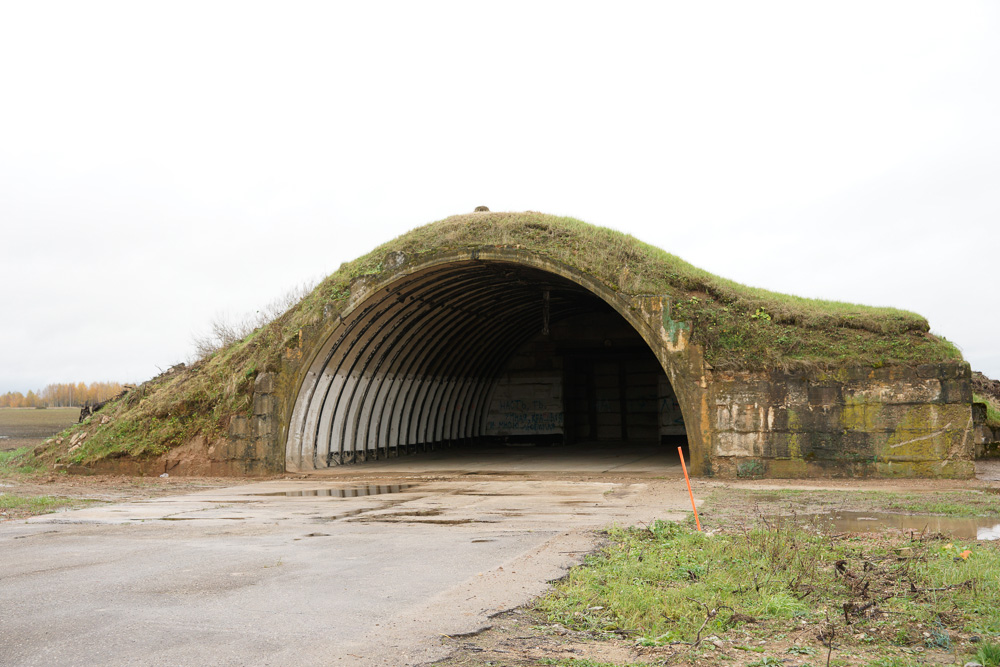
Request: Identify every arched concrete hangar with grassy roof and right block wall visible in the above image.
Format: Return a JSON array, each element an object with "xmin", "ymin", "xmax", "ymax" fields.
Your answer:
[{"xmin": 238, "ymin": 212, "xmax": 973, "ymax": 477}]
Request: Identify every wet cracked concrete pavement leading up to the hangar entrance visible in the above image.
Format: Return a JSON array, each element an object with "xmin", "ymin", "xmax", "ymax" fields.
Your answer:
[{"xmin": 0, "ymin": 449, "xmax": 700, "ymax": 666}]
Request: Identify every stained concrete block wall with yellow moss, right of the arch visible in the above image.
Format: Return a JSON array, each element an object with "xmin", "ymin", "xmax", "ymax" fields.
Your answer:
[{"xmin": 706, "ymin": 363, "xmax": 974, "ymax": 477}]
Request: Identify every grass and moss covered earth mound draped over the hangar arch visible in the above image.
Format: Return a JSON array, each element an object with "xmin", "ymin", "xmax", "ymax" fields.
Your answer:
[{"xmin": 46, "ymin": 212, "xmax": 960, "ymax": 463}]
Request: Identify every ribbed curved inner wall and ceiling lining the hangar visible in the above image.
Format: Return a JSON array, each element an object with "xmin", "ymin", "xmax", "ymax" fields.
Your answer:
[{"xmin": 286, "ymin": 257, "xmax": 700, "ymax": 470}]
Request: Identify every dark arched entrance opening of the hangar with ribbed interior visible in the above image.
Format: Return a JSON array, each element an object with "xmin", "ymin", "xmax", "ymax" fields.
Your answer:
[{"xmin": 286, "ymin": 261, "xmax": 686, "ymax": 470}]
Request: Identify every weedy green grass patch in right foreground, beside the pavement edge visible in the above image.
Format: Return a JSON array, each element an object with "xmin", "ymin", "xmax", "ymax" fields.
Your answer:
[{"xmin": 537, "ymin": 521, "xmax": 1000, "ymax": 664}]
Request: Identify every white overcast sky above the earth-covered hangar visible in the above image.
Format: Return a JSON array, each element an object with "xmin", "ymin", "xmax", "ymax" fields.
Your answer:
[{"xmin": 0, "ymin": 0, "xmax": 1000, "ymax": 392}]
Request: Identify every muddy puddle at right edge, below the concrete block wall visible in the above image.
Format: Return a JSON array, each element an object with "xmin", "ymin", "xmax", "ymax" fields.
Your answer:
[{"xmin": 782, "ymin": 512, "xmax": 1000, "ymax": 540}]
